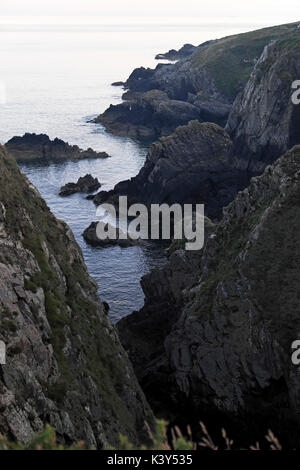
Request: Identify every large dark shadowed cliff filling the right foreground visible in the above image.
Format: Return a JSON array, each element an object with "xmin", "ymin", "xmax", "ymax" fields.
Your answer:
[{"xmin": 118, "ymin": 147, "xmax": 300, "ymax": 446}]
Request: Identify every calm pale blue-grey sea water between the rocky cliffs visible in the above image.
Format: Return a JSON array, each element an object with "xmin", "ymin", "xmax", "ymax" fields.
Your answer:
[{"xmin": 0, "ymin": 25, "xmax": 268, "ymax": 322}]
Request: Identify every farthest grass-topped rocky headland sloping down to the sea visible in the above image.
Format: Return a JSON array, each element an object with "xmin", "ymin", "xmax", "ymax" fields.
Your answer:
[{"xmin": 94, "ymin": 23, "xmax": 298, "ymax": 140}]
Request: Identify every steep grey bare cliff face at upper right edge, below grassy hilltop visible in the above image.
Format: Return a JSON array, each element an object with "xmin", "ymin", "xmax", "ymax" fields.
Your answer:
[{"xmin": 226, "ymin": 34, "xmax": 300, "ymax": 174}]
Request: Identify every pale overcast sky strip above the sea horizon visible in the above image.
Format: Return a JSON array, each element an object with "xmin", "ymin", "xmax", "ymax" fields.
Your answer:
[{"xmin": 0, "ymin": 0, "xmax": 300, "ymax": 25}]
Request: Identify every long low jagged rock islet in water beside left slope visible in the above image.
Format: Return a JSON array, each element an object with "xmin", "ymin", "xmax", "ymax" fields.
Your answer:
[{"xmin": 5, "ymin": 133, "xmax": 109, "ymax": 161}]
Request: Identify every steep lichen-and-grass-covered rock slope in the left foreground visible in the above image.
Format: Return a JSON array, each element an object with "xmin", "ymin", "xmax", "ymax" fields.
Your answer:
[{"xmin": 0, "ymin": 147, "xmax": 152, "ymax": 448}]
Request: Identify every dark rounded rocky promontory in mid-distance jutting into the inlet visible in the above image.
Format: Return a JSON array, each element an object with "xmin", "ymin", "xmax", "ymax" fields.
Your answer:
[{"xmin": 94, "ymin": 121, "xmax": 245, "ymax": 217}]
